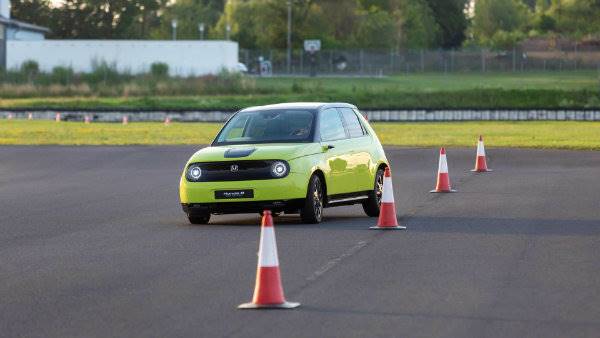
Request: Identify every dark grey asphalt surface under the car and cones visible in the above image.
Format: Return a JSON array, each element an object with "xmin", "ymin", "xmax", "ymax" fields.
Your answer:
[{"xmin": 0, "ymin": 147, "xmax": 600, "ymax": 337}]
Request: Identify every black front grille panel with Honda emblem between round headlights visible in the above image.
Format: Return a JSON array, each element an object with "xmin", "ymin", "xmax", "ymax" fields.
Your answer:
[{"xmin": 188, "ymin": 160, "xmax": 284, "ymax": 182}]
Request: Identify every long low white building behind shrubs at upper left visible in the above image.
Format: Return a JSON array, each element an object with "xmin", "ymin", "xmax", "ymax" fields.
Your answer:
[{"xmin": 0, "ymin": 0, "xmax": 238, "ymax": 76}]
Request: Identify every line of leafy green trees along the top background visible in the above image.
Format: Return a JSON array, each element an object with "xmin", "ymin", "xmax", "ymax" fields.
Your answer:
[{"xmin": 12, "ymin": 0, "xmax": 600, "ymax": 49}]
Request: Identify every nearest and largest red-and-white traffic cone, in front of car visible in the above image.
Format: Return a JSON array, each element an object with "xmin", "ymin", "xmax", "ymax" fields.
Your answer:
[{"xmin": 238, "ymin": 210, "xmax": 300, "ymax": 309}]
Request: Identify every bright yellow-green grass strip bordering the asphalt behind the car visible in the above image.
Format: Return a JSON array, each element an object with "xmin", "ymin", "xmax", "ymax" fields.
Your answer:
[{"xmin": 0, "ymin": 120, "xmax": 600, "ymax": 150}]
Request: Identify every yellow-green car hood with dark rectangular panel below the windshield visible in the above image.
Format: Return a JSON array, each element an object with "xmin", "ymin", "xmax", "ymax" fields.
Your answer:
[{"xmin": 189, "ymin": 143, "xmax": 321, "ymax": 162}]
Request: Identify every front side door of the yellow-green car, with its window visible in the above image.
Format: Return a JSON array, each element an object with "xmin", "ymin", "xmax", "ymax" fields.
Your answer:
[{"xmin": 319, "ymin": 108, "xmax": 356, "ymax": 196}]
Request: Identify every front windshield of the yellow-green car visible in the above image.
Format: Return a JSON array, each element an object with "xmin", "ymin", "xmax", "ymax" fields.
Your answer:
[{"xmin": 215, "ymin": 109, "xmax": 315, "ymax": 145}]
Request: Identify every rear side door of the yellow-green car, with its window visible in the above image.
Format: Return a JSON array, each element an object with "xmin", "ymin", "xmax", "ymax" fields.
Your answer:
[{"xmin": 338, "ymin": 108, "xmax": 374, "ymax": 191}]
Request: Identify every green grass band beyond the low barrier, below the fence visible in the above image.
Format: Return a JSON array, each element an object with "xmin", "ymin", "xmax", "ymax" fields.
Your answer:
[{"xmin": 0, "ymin": 71, "xmax": 600, "ymax": 110}]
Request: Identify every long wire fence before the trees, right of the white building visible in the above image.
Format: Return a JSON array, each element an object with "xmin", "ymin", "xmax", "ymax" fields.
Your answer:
[{"xmin": 239, "ymin": 48, "xmax": 600, "ymax": 76}]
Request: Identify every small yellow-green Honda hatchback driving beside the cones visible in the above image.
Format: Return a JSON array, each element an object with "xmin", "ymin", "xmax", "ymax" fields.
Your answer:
[{"xmin": 179, "ymin": 103, "xmax": 389, "ymax": 224}]
